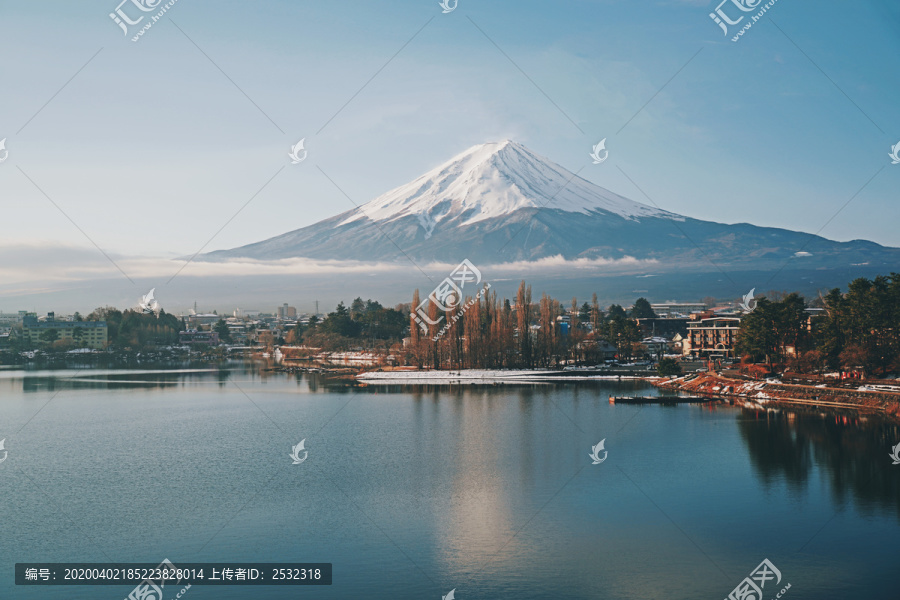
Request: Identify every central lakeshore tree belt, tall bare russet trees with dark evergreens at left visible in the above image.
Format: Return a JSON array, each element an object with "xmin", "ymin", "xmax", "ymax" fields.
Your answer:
[{"xmin": 281, "ymin": 281, "xmax": 656, "ymax": 369}]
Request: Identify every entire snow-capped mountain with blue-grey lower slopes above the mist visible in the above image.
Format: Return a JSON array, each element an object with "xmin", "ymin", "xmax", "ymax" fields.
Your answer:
[{"xmin": 198, "ymin": 140, "xmax": 900, "ymax": 274}]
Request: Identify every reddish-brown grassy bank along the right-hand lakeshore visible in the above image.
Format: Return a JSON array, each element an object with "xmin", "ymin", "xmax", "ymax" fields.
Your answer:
[{"xmin": 652, "ymin": 373, "xmax": 900, "ymax": 419}]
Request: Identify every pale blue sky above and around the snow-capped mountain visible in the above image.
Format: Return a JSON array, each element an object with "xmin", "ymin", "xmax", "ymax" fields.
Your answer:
[{"xmin": 0, "ymin": 0, "xmax": 900, "ymax": 264}]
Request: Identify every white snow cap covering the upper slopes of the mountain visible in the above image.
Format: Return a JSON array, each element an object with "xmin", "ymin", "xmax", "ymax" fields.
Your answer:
[{"xmin": 338, "ymin": 140, "xmax": 680, "ymax": 238}]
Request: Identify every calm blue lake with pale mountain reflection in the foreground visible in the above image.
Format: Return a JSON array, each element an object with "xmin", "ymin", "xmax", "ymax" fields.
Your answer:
[{"xmin": 0, "ymin": 366, "xmax": 900, "ymax": 600}]
